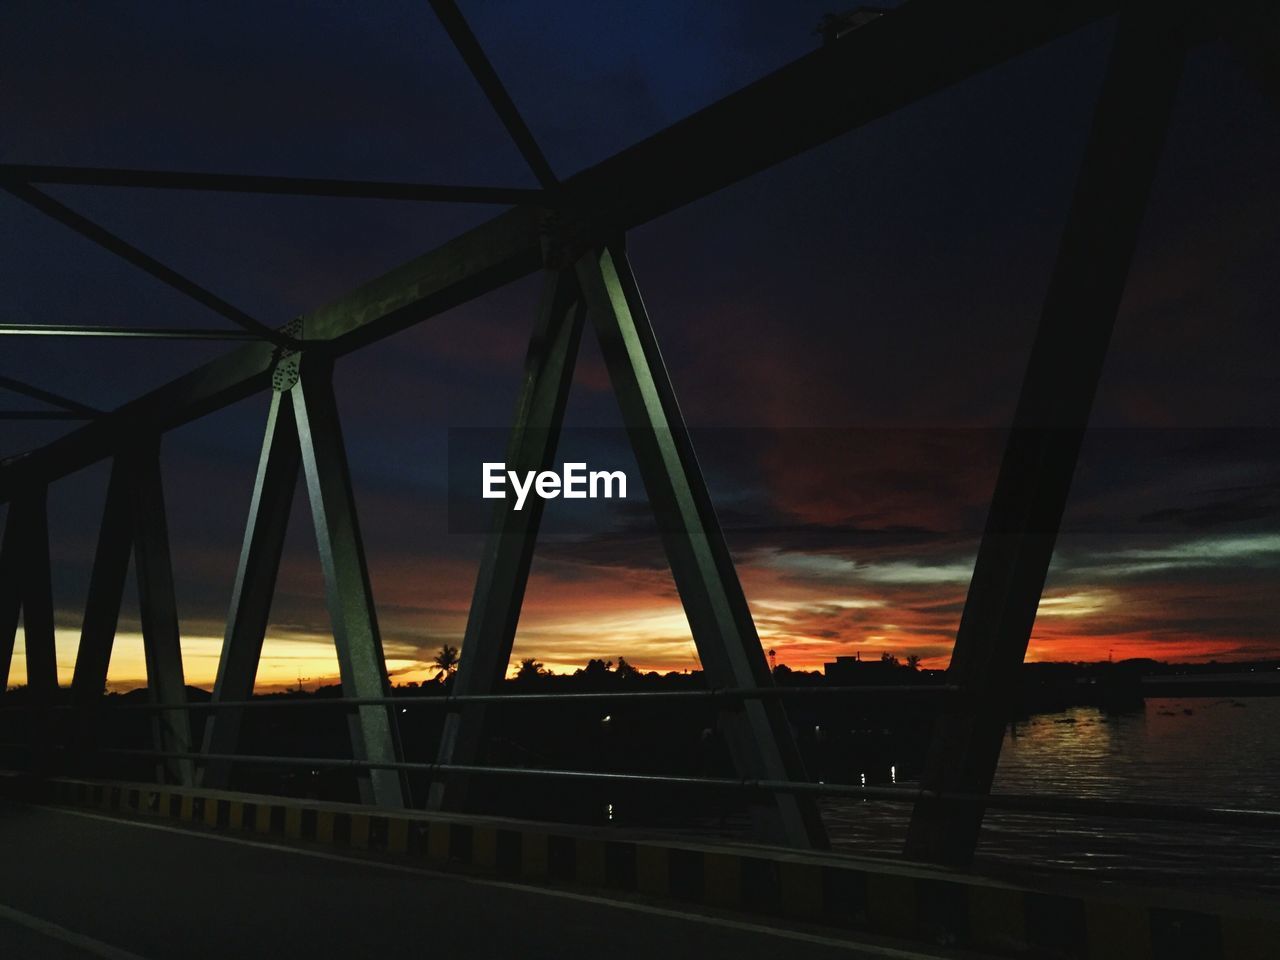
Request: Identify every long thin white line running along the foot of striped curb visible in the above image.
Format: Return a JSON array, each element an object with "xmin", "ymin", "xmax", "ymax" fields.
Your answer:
[{"xmin": 41, "ymin": 806, "xmax": 946, "ymax": 960}]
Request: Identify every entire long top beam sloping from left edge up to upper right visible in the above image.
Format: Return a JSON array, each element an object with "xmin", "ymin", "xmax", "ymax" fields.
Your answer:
[{"xmin": 0, "ymin": 0, "xmax": 1120, "ymax": 499}]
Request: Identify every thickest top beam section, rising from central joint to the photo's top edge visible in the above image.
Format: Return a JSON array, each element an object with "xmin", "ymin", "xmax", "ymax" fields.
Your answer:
[{"xmin": 564, "ymin": 0, "xmax": 1121, "ymax": 231}]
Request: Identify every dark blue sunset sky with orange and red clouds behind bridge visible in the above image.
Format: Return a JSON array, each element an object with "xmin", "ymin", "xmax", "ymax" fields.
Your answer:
[{"xmin": 0, "ymin": 0, "xmax": 1280, "ymax": 687}]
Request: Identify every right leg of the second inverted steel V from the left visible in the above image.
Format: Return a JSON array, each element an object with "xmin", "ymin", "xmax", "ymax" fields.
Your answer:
[{"xmin": 129, "ymin": 438, "xmax": 195, "ymax": 786}]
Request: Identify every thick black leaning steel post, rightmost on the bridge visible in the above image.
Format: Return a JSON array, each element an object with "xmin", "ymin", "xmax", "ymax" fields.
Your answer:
[{"xmin": 906, "ymin": 4, "xmax": 1184, "ymax": 865}]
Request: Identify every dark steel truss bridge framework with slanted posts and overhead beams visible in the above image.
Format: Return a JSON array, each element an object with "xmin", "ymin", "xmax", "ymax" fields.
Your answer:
[{"xmin": 0, "ymin": 0, "xmax": 1280, "ymax": 957}]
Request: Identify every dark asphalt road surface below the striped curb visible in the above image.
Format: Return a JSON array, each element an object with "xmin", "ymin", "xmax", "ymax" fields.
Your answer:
[{"xmin": 0, "ymin": 804, "xmax": 962, "ymax": 960}]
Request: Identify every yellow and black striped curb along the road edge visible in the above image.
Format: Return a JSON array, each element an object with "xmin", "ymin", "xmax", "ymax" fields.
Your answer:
[{"xmin": 0, "ymin": 774, "xmax": 1280, "ymax": 960}]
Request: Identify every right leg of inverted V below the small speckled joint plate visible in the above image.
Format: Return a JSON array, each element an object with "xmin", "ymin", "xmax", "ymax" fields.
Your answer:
[{"xmin": 289, "ymin": 356, "xmax": 407, "ymax": 806}]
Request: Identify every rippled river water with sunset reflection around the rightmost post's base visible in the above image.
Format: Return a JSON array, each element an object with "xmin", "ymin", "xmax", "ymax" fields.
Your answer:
[{"xmin": 824, "ymin": 698, "xmax": 1280, "ymax": 893}]
